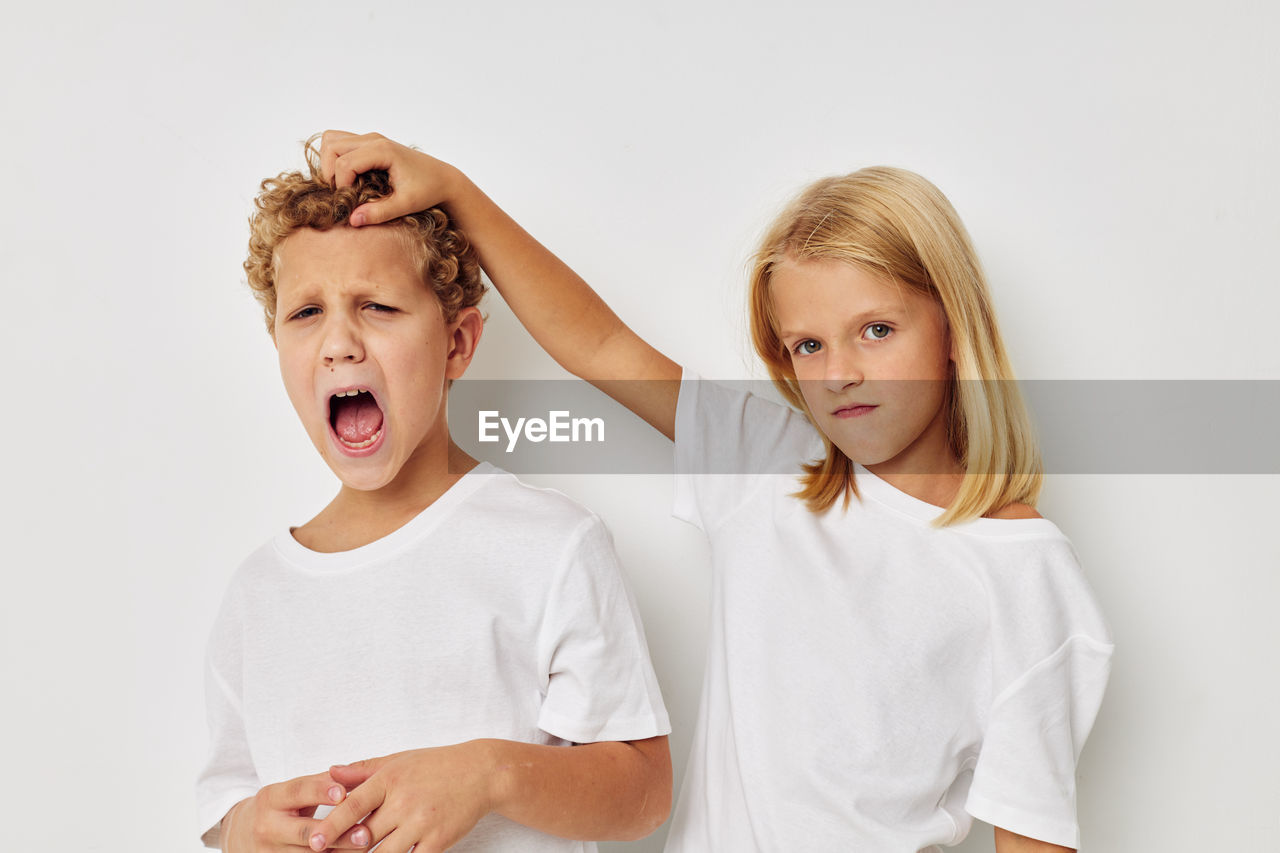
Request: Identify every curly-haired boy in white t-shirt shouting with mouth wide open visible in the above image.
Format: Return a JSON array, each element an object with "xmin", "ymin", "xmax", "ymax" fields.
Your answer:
[{"xmin": 197, "ymin": 143, "xmax": 671, "ymax": 853}]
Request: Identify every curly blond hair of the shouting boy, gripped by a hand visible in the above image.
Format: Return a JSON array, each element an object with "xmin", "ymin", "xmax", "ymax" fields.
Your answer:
[{"xmin": 244, "ymin": 134, "xmax": 485, "ymax": 334}]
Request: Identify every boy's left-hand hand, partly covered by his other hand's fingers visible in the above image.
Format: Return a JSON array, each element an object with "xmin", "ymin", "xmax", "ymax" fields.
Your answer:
[{"xmin": 221, "ymin": 774, "xmax": 369, "ymax": 853}]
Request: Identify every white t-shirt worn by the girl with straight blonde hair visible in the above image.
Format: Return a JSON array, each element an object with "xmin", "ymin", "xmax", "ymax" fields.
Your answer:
[{"xmin": 667, "ymin": 370, "xmax": 1112, "ymax": 853}]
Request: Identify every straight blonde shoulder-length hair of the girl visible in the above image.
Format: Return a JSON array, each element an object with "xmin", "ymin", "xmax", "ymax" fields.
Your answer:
[{"xmin": 749, "ymin": 167, "xmax": 1043, "ymax": 526}]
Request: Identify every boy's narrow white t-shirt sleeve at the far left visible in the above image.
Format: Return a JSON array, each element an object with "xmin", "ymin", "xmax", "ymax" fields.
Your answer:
[{"xmin": 196, "ymin": 578, "xmax": 260, "ymax": 848}]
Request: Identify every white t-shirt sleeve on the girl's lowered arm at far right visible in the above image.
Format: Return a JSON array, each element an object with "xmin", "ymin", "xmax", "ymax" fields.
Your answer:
[{"xmin": 965, "ymin": 542, "xmax": 1114, "ymax": 848}]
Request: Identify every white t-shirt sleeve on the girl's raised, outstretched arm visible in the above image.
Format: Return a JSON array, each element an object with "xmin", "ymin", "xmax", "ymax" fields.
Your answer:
[{"xmin": 672, "ymin": 369, "xmax": 823, "ymax": 532}]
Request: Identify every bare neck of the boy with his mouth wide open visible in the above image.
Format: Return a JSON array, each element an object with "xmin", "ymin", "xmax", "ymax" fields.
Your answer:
[{"xmin": 292, "ymin": 439, "xmax": 479, "ymax": 553}]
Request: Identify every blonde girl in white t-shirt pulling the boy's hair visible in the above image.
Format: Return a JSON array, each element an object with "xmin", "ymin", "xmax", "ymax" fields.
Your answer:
[{"xmin": 323, "ymin": 132, "xmax": 1112, "ymax": 853}]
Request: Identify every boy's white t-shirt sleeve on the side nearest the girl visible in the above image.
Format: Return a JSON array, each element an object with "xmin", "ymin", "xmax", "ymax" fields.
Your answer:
[{"xmin": 538, "ymin": 516, "xmax": 671, "ymax": 743}]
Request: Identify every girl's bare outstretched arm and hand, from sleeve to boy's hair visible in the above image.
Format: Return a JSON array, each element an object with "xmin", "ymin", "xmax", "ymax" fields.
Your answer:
[{"xmin": 321, "ymin": 131, "xmax": 680, "ymax": 438}]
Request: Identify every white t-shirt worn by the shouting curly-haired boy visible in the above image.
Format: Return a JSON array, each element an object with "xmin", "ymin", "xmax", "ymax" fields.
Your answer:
[{"xmin": 197, "ymin": 464, "xmax": 671, "ymax": 850}]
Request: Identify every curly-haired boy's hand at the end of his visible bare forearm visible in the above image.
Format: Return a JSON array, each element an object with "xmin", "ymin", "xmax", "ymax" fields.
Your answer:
[{"xmin": 304, "ymin": 742, "xmax": 492, "ymax": 853}]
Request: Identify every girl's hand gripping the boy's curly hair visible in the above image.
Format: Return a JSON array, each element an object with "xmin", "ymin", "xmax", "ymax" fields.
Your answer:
[{"xmin": 320, "ymin": 131, "xmax": 461, "ymax": 228}]
